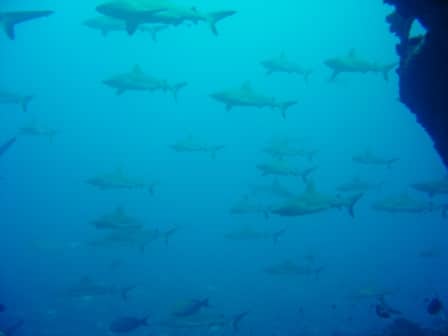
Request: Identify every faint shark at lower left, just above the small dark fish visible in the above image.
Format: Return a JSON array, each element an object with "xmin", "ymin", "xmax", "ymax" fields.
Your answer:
[{"xmin": 64, "ymin": 277, "xmax": 135, "ymax": 301}]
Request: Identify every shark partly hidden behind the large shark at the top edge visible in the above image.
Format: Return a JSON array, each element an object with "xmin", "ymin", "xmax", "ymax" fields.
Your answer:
[{"xmin": 83, "ymin": 15, "xmax": 169, "ymax": 42}]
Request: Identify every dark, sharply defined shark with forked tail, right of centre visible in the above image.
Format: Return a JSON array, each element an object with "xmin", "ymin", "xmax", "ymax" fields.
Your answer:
[{"xmin": 271, "ymin": 181, "xmax": 363, "ymax": 218}]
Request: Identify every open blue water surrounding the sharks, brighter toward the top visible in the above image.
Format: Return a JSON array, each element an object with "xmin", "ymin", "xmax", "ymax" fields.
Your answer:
[{"xmin": 0, "ymin": 0, "xmax": 448, "ymax": 336}]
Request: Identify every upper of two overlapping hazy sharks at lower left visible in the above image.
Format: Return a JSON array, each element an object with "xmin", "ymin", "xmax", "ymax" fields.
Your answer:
[{"xmin": 91, "ymin": 206, "xmax": 143, "ymax": 230}]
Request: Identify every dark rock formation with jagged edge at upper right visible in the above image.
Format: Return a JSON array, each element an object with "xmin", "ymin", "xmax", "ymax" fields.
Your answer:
[{"xmin": 384, "ymin": 0, "xmax": 448, "ymax": 167}]
